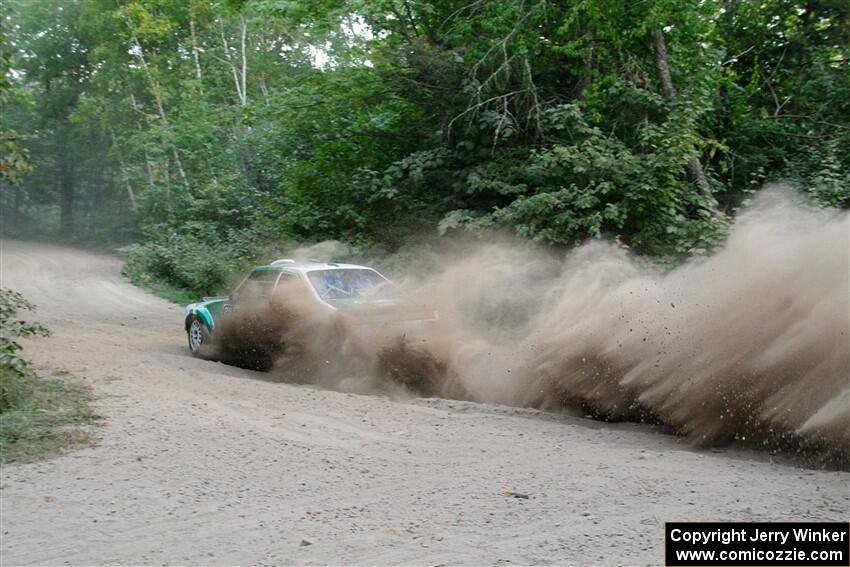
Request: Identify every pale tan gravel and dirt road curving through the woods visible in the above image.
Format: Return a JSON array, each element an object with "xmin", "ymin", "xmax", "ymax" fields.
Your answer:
[{"xmin": 0, "ymin": 241, "xmax": 850, "ymax": 566}]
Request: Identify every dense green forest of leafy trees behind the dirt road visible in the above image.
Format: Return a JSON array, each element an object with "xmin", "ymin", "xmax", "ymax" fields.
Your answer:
[{"xmin": 0, "ymin": 0, "xmax": 850, "ymax": 293}]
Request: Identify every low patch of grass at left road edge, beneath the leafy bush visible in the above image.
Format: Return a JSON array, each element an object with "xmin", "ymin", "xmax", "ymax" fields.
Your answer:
[{"xmin": 0, "ymin": 366, "xmax": 100, "ymax": 463}]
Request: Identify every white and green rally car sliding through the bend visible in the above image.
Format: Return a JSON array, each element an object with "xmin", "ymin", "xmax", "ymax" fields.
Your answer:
[{"xmin": 184, "ymin": 259, "xmax": 439, "ymax": 362}]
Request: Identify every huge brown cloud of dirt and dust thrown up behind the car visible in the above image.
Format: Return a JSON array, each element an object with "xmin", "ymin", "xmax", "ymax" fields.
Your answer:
[{"xmin": 220, "ymin": 190, "xmax": 850, "ymax": 465}]
